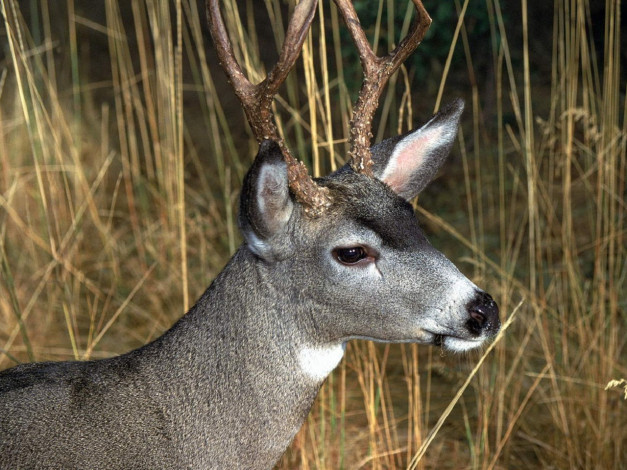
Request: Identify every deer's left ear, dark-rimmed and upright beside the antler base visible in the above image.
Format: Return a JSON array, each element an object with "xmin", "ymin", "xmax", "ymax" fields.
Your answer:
[{"xmin": 239, "ymin": 140, "xmax": 293, "ymax": 258}]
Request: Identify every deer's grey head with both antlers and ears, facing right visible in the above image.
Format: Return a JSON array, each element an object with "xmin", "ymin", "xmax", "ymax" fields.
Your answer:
[{"xmin": 207, "ymin": 0, "xmax": 500, "ymax": 350}]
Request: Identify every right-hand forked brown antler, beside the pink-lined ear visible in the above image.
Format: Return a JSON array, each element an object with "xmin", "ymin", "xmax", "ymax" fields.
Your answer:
[{"xmin": 334, "ymin": 0, "xmax": 431, "ymax": 176}]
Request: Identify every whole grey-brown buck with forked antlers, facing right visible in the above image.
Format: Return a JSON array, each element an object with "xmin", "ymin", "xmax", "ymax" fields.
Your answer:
[{"xmin": 0, "ymin": 0, "xmax": 500, "ymax": 469}]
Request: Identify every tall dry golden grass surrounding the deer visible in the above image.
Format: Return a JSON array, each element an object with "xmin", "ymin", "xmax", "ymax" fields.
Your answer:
[{"xmin": 0, "ymin": 0, "xmax": 627, "ymax": 469}]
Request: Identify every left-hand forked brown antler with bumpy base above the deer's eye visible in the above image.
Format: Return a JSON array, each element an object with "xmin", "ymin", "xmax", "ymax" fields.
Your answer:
[{"xmin": 207, "ymin": 0, "xmax": 331, "ymax": 216}]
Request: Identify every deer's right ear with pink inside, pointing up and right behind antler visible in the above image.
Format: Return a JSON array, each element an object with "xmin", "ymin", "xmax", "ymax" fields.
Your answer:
[{"xmin": 371, "ymin": 99, "xmax": 464, "ymax": 200}]
